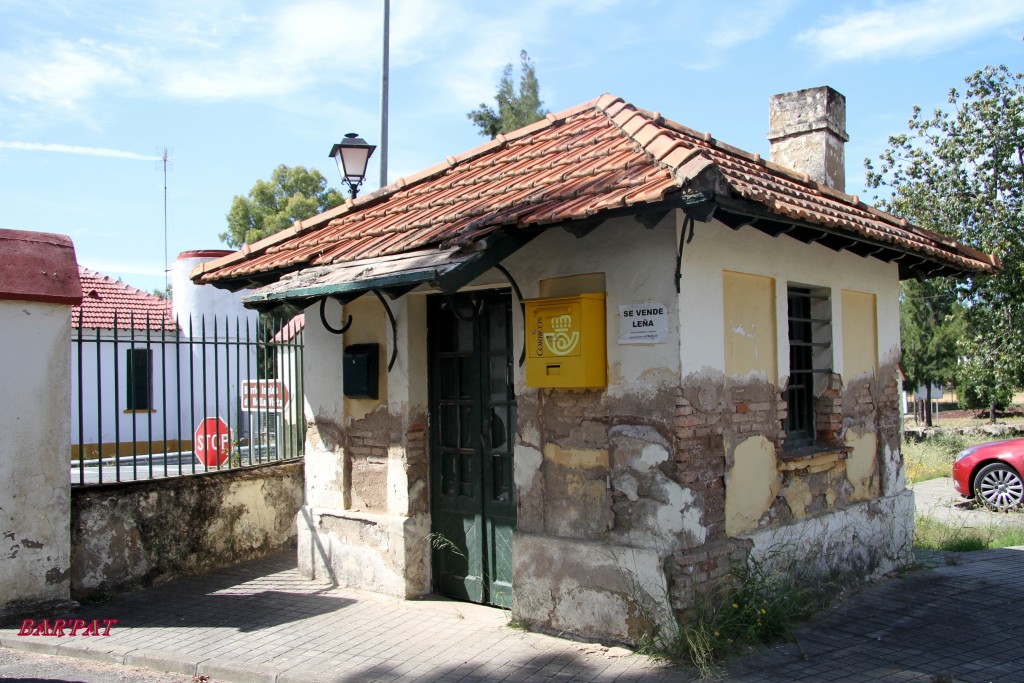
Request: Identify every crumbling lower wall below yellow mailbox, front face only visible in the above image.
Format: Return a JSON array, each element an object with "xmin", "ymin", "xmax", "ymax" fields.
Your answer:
[{"xmin": 513, "ymin": 385, "xmax": 708, "ymax": 642}]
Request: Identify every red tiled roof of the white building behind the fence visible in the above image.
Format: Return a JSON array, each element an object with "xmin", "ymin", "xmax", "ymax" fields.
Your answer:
[{"xmin": 71, "ymin": 265, "xmax": 178, "ymax": 332}]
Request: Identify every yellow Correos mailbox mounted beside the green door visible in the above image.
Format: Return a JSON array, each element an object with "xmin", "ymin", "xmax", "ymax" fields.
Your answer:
[{"xmin": 523, "ymin": 292, "xmax": 608, "ymax": 389}]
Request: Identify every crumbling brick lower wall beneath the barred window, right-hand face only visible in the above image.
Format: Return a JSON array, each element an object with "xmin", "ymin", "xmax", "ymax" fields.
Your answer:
[{"xmin": 669, "ymin": 364, "xmax": 912, "ymax": 612}]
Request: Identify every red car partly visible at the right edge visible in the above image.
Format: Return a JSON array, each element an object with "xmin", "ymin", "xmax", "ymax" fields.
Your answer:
[{"xmin": 953, "ymin": 438, "xmax": 1024, "ymax": 510}]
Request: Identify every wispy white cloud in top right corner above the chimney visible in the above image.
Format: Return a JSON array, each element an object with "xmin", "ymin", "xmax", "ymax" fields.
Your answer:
[{"xmin": 797, "ymin": 0, "xmax": 1024, "ymax": 61}]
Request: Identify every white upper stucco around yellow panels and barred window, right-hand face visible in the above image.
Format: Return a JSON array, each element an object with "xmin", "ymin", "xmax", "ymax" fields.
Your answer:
[{"xmin": 679, "ymin": 214, "xmax": 899, "ymax": 384}]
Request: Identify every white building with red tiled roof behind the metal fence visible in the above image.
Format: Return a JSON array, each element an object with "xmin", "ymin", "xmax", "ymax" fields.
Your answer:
[{"xmin": 72, "ymin": 250, "xmax": 258, "ymax": 460}]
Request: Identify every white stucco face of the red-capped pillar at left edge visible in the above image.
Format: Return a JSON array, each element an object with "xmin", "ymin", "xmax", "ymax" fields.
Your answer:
[{"xmin": 0, "ymin": 301, "xmax": 71, "ymax": 615}]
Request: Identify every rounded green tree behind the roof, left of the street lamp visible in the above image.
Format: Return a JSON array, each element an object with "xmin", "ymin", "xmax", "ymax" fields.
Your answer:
[{"xmin": 220, "ymin": 164, "xmax": 344, "ymax": 248}]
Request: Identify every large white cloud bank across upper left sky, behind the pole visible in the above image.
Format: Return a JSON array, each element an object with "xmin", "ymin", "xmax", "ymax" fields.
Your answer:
[{"xmin": 0, "ymin": 0, "xmax": 622, "ymax": 112}]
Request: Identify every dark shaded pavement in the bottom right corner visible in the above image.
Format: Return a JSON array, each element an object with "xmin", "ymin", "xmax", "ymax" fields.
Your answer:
[{"xmin": 728, "ymin": 548, "xmax": 1024, "ymax": 683}]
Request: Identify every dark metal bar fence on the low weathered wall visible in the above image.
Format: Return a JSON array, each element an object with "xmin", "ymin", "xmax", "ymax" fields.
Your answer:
[{"xmin": 71, "ymin": 315, "xmax": 305, "ymax": 485}]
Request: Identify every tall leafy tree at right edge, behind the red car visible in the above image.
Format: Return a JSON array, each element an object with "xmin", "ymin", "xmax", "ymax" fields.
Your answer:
[{"xmin": 865, "ymin": 66, "xmax": 1024, "ymax": 421}]
